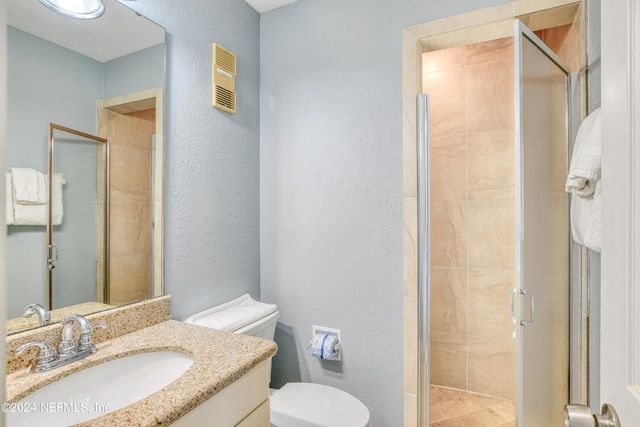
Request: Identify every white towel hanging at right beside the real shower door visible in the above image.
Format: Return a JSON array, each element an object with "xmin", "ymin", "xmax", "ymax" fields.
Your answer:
[{"xmin": 565, "ymin": 108, "xmax": 602, "ymax": 252}]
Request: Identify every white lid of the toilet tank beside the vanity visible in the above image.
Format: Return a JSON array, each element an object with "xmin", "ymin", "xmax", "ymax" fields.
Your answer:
[{"xmin": 185, "ymin": 294, "xmax": 280, "ymax": 341}]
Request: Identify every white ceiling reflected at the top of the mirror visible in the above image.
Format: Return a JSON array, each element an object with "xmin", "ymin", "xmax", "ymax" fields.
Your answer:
[{"xmin": 7, "ymin": 0, "xmax": 164, "ymax": 62}]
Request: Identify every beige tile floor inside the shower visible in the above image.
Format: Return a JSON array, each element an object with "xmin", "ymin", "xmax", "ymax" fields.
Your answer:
[{"xmin": 430, "ymin": 385, "xmax": 515, "ymax": 427}]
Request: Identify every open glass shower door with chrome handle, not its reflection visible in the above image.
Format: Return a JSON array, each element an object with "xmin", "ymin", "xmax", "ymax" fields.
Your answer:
[{"xmin": 512, "ymin": 21, "xmax": 570, "ymax": 427}]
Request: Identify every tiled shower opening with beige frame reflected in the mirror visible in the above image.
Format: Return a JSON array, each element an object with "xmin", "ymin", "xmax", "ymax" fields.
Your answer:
[{"xmin": 98, "ymin": 88, "xmax": 163, "ymax": 305}]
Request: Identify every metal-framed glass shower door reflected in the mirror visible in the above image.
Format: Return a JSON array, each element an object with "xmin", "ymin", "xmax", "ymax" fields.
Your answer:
[{"xmin": 47, "ymin": 123, "xmax": 109, "ymax": 310}]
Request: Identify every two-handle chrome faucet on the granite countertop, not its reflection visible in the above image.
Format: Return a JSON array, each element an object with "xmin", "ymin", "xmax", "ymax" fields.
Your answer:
[{"xmin": 16, "ymin": 314, "xmax": 107, "ymax": 372}]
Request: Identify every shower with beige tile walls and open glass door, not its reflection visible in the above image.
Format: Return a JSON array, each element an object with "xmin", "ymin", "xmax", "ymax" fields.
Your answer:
[{"xmin": 417, "ymin": 21, "xmax": 571, "ymax": 426}]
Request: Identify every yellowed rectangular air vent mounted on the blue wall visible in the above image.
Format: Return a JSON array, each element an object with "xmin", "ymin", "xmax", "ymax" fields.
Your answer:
[{"xmin": 212, "ymin": 43, "xmax": 236, "ymax": 113}]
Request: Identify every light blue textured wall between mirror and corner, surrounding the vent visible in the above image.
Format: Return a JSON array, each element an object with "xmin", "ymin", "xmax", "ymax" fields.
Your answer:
[{"xmin": 123, "ymin": 0, "xmax": 260, "ymax": 319}]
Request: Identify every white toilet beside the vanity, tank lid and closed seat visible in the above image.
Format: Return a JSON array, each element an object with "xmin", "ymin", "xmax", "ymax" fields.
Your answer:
[{"xmin": 185, "ymin": 294, "xmax": 371, "ymax": 427}]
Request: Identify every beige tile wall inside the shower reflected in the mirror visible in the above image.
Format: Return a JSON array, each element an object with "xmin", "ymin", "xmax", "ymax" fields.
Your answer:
[{"xmin": 107, "ymin": 109, "xmax": 155, "ymax": 305}]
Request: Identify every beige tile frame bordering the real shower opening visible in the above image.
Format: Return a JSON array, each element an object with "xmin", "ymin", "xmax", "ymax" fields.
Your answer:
[{"xmin": 402, "ymin": 0, "xmax": 586, "ymax": 427}]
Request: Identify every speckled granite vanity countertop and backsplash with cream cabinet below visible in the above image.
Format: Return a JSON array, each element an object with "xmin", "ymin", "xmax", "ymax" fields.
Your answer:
[{"xmin": 6, "ymin": 296, "xmax": 277, "ymax": 427}]
